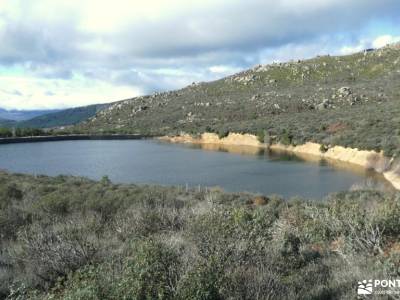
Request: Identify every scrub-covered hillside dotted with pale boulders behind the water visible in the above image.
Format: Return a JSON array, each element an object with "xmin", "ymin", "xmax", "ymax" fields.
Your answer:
[{"xmin": 76, "ymin": 44, "xmax": 400, "ymax": 155}]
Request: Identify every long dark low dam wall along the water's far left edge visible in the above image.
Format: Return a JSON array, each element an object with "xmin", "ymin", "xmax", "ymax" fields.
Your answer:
[{"xmin": 0, "ymin": 134, "xmax": 151, "ymax": 145}]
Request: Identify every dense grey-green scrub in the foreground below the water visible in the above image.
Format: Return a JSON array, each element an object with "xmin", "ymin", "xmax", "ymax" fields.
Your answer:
[{"xmin": 0, "ymin": 173, "xmax": 400, "ymax": 299}]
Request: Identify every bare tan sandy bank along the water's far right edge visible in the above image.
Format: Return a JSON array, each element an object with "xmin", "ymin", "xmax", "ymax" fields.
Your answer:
[{"xmin": 160, "ymin": 133, "xmax": 400, "ymax": 190}]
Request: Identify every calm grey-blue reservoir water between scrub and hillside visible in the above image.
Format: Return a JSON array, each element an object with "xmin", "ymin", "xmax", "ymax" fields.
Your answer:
[{"xmin": 0, "ymin": 140, "xmax": 390, "ymax": 199}]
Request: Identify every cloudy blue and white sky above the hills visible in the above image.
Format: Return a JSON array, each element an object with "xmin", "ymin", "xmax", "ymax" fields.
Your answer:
[{"xmin": 0, "ymin": 0, "xmax": 400, "ymax": 109}]
